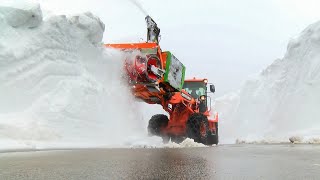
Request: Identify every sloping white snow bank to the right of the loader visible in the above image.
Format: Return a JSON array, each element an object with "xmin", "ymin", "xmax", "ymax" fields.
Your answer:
[{"xmin": 216, "ymin": 22, "xmax": 320, "ymax": 143}]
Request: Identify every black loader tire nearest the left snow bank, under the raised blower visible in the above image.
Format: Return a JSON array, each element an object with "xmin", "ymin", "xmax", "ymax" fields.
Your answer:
[{"xmin": 148, "ymin": 114, "xmax": 170, "ymax": 136}]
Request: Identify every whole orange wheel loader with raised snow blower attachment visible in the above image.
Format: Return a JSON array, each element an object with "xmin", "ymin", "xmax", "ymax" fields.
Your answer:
[{"xmin": 105, "ymin": 16, "xmax": 218, "ymax": 145}]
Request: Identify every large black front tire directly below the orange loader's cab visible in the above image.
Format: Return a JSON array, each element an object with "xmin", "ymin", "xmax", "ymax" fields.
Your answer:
[{"xmin": 187, "ymin": 113, "xmax": 210, "ymax": 144}]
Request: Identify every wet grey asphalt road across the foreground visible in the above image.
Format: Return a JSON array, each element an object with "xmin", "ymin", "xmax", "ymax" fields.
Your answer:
[{"xmin": 0, "ymin": 144, "xmax": 320, "ymax": 180}]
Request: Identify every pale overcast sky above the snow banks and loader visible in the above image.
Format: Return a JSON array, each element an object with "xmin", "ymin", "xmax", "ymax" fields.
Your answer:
[{"xmin": 38, "ymin": 0, "xmax": 320, "ymax": 96}]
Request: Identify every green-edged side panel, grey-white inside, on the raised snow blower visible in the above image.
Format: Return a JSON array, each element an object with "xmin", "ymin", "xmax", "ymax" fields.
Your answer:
[{"xmin": 164, "ymin": 51, "xmax": 186, "ymax": 91}]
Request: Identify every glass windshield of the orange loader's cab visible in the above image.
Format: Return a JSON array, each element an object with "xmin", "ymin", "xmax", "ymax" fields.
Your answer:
[{"xmin": 183, "ymin": 81, "xmax": 206, "ymax": 98}]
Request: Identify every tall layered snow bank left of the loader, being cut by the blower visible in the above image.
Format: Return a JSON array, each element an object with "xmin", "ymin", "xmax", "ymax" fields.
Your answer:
[{"xmin": 0, "ymin": 1, "xmax": 146, "ymax": 149}]
